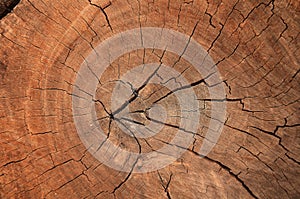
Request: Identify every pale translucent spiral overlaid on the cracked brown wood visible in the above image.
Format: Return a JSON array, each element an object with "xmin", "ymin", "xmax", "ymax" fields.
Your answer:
[{"xmin": 72, "ymin": 27, "xmax": 226, "ymax": 173}]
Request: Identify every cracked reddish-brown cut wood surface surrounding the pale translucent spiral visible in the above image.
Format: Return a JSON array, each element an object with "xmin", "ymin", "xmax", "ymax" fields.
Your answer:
[{"xmin": 0, "ymin": 0, "xmax": 300, "ymax": 199}]
